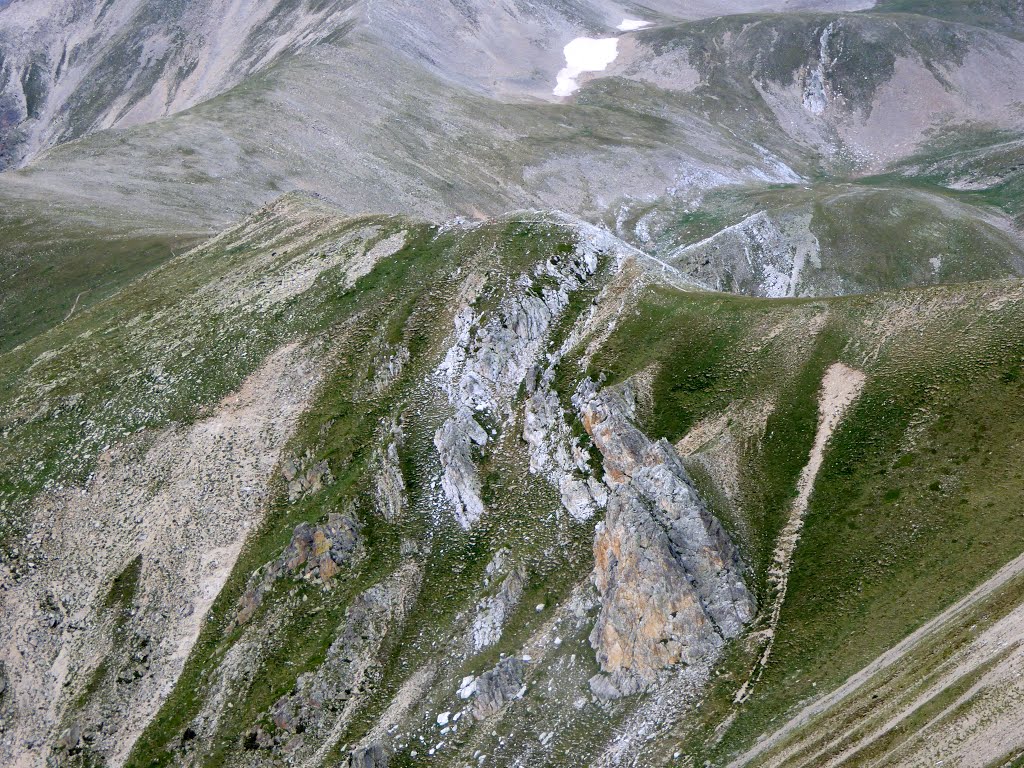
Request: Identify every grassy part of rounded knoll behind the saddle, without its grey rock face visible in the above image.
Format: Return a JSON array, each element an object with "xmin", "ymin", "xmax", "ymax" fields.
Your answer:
[{"xmin": 628, "ymin": 180, "xmax": 1024, "ymax": 296}]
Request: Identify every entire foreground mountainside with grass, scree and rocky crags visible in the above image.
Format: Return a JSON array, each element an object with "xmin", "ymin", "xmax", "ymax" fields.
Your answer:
[{"xmin": 3, "ymin": 197, "xmax": 1024, "ymax": 765}]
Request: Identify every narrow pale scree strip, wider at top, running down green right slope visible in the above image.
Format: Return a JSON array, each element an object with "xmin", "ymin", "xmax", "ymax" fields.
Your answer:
[{"xmin": 735, "ymin": 362, "xmax": 867, "ymax": 705}]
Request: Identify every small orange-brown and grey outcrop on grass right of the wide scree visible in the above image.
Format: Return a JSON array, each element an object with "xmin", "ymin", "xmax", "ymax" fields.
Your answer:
[{"xmin": 234, "ymin": 512, "xmax": 359, "ymax": 625}]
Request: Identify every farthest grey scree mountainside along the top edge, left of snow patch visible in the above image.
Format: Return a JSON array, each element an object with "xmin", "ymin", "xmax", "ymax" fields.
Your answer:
[{"xmin": 0, "ymin": 0, "xmax": 869, "ymax": 170}]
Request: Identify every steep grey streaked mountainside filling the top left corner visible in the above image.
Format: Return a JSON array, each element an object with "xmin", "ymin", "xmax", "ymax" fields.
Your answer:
[{"xmin": 0, "ymin": 0, "xmax": 355, "ymax": 170}]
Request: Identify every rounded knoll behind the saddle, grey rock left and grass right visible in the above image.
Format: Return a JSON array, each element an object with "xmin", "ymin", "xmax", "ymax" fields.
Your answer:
[{"xmin": 615, "ymin": 178, "xmax": 1024, "ymax": 298}]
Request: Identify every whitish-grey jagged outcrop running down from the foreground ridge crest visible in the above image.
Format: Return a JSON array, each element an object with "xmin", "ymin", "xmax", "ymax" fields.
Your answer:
[{"xmin": 434, "ymin": 230, "xmax": 598, "ymax": 528}]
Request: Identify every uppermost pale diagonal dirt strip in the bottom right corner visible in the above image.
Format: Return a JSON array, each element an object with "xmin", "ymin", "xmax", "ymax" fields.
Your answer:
[{"xmin": 728, "ymin": 554, "xmax": 1024, "ymax": 768}]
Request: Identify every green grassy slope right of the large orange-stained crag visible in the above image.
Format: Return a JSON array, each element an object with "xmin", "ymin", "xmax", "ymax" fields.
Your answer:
[{"xmin": 581, "ymin": 283, "xmax": 1024, "ymax": 764}]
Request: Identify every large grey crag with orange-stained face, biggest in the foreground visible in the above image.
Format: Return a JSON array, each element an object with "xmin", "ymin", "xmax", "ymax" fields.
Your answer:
[{"xmin": 573, "ymin": 382, "xmax": 756, "ymax": 697}]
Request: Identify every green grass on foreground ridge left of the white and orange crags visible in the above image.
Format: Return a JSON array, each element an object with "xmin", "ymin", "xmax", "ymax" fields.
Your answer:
[{"xmin": 0, "ymin": 196, "xmax": 614, "ymax": 765}]
